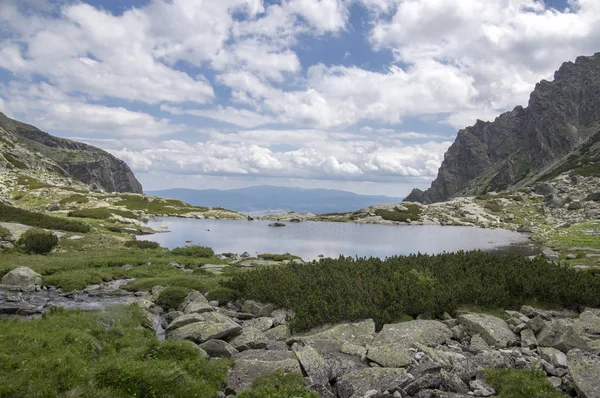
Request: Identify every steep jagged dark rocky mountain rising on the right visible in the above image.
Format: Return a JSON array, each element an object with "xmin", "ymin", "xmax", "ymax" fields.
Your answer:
[{"xmin": 405, "ymin": 53, "xmax": 600, "ymax": 203}]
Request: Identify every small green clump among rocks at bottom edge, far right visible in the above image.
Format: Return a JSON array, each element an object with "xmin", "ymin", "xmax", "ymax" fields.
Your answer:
[{"xmin": 485, "ymin": 368, "xmax": 564, "ymax": 398}]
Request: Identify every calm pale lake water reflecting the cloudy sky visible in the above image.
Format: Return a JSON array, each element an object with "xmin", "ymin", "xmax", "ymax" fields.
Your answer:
[{"xmin": 140, "ymin": 218, "xmax": 535, "ymax": 260}]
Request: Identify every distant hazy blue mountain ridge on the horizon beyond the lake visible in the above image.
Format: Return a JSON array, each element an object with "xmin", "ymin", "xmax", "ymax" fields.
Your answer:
[{"xmin": 147, "ymin": 185, "xmax": 402, "ymax": 214}]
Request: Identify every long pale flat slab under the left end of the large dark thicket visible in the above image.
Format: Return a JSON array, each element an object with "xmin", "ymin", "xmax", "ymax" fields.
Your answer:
[{"xmin": 288, "ymin": 319, "xmax": 375, "ymax": 346}]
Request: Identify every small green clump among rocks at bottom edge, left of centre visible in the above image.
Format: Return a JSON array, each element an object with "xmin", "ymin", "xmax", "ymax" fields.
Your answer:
[{"xmin": 236, "ymin": 370, "xmax": 319, "ymax": 398}]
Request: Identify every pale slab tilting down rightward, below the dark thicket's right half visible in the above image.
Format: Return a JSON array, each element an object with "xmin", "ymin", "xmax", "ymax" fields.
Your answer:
[{"xmin": 458, "ymin": 314, "xmax": 517, "ymax": 347}]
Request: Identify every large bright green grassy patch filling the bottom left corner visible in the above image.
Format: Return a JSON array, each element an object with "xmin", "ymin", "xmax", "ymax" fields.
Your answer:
[{"xmin": 0, "ymin": 306, "xmax": 230, "ymax": 398}]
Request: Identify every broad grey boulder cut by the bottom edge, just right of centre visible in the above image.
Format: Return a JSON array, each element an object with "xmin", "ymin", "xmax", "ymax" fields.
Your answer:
[{"xmin": 336, "ymin": 368, "xmax": 412, "ymax": 398}]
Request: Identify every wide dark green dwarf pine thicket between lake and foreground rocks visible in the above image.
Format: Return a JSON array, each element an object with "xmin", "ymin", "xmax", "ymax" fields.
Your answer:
[{"xmin": 224, "ymin": 251, "xmax": 600, "ymax": 331}]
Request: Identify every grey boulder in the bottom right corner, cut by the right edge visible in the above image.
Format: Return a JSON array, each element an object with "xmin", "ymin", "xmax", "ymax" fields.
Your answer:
[{"xmin": 567, "ymin": 349, "xmax": 600, "ymax": 398}]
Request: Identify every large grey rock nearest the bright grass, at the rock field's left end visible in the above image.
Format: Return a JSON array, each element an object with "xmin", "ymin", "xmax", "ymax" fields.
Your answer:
[{"xmin": 168, "ymin": 312, "xmax": 242, "ymax": 343}]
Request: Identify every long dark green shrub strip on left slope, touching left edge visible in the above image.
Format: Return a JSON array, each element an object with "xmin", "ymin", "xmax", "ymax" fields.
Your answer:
[{"xmin": 0, "ymin": 203, "xmax": 90, "ymax": 233}]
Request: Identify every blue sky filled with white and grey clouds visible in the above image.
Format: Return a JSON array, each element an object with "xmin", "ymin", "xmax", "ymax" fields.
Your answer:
[{"xmin": 0, "ymin": 0, "xmax": 600, "ymax": 196}]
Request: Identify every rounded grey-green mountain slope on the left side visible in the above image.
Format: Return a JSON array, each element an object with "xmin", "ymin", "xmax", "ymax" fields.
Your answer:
[{"xmin": 0, "ymin": 112, "xmax": 143, "ymax": 193}]
